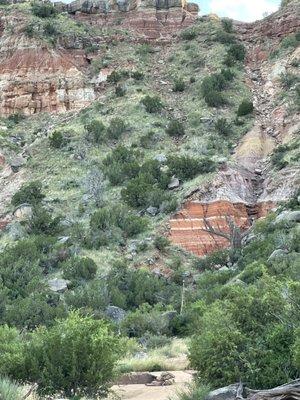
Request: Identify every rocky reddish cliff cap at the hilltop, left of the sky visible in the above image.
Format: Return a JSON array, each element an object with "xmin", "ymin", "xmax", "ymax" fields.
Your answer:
[{"xmin": 65, "ymin": 0, "xmax": 199, "ymax": 41}]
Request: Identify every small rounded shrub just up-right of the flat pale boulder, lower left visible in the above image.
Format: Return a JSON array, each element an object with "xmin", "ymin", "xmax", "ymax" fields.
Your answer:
[{"xmin": 63, "ymin": 257, "xmax": 97, "ymax": 281}]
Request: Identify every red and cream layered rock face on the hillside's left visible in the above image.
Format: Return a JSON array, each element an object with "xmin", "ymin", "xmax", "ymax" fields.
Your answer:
[{"xmin": 0, "ymin": 38, "xmax": 95, "ymax": 116}]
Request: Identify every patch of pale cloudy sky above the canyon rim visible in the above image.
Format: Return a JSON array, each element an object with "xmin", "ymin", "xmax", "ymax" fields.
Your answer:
[{"xmin": 196, "ymin": 0, "xmax": 280, "ymax": 22}]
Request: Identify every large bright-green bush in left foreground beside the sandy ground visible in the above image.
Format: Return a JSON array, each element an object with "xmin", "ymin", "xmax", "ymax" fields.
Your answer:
[{"xmin": 26, "ymin": 312, "xmax": 121, "ymax": 397}]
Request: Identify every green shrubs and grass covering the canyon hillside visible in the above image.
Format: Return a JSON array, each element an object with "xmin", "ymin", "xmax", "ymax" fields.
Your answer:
[{"xmin": 0, "ymin": 3, "xmax": 300, "ymax": 400}]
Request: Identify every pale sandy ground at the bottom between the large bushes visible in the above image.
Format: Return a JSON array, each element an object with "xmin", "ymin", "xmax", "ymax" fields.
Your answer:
[{"xmin": 109, "ymin": 371, "xmax": 193, "ymax": 400}]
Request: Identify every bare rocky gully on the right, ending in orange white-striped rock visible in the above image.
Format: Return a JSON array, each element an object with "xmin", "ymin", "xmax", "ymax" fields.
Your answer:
[{"xmin": 170, "ymin": 3, "xmax": 300, "ymax": 256}]
